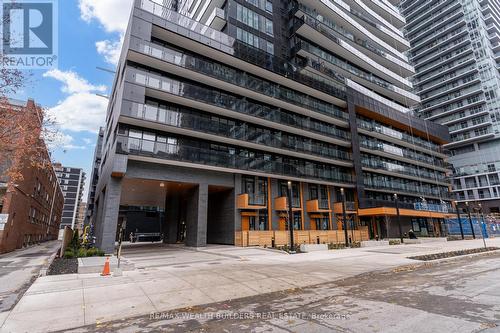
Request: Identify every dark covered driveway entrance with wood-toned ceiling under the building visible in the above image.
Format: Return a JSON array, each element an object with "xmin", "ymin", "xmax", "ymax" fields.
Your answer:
[{"xmin": 117, "ymin": 178, "xmax": 234, "ymax": 246}]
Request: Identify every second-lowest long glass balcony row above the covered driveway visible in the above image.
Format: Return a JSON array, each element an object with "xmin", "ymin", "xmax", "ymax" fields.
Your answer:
[{"xmin": 122, "ymin": 101, "xmax": 352, "ymax": 161}]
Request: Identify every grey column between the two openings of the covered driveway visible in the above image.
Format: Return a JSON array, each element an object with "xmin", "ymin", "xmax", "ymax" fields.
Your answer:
[{"xmin": 186, "ymin": 184, "xmax": 208, "ymax": 247}]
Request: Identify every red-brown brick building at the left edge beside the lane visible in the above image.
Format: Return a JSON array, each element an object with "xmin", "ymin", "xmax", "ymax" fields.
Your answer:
[{"xmin": 0, "ymin": 100, "xmax": 64, "ymax": 253}]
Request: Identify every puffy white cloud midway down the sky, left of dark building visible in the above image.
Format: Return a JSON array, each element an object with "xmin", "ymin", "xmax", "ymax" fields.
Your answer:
[{"xmin": 48, "ymin": 92, "xmax": 108, "ymax": 133}]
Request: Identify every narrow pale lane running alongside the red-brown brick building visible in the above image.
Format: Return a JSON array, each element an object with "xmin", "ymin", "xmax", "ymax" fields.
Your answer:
[{"xmin": 0, "ymin": 241, "xmax": 60, "ymax": 327}]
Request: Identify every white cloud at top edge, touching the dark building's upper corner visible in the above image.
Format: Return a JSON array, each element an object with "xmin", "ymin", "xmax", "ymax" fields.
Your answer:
[{"xmin": 79, "ymin": 0, "xmax": 133, "ymax": 34}]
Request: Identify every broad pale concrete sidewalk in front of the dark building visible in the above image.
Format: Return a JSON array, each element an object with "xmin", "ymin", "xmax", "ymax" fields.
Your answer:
[{"xmin": 0, "ymin": 239, "xmax": 500, "ymax": 333}]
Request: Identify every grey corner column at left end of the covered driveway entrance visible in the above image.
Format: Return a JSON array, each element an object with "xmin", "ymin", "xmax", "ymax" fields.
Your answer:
[{"xmin": 97, "ymin": 177, "xmax": 121, "ymax": 253}]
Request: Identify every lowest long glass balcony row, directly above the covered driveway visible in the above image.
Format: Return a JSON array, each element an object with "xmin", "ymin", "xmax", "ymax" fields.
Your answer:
[{"xmin": 116, "ymin": 135, "xmax": 353, "ymax": 184}]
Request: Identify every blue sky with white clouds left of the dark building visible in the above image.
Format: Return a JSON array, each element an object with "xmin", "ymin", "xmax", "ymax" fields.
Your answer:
[{"xmin": 11, "ymin": 0, "xmax": 135, "ymax": 200}]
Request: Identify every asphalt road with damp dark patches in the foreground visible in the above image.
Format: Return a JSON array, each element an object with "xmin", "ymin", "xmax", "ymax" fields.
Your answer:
[{"xmin": 65, "ymin": 253, "xmax": 500, "ymax": 333}]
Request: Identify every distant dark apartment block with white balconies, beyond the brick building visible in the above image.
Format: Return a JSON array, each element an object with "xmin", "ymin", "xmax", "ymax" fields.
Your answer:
[{"xmin": 54, "ymin": 163, "xmax": 85, "ymax": 230}]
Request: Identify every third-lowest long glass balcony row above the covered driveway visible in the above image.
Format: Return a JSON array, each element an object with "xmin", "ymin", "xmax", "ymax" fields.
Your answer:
[{"xmin": 127, "ymin": 70, "xmax": 350, "ymax": 141}]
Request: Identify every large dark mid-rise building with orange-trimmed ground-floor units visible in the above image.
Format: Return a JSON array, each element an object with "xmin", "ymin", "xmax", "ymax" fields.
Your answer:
[{"xmin": 94, "ymin": 0, "xmax": 450, "ymax": 251}]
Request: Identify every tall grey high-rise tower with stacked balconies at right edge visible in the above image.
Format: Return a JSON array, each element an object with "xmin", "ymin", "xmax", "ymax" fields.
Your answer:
[{"xmin": 400, "ymin": 0, "xmax": 500, "ymax": 213}]
